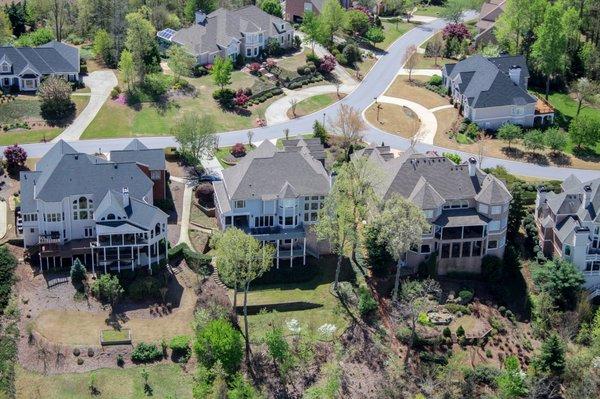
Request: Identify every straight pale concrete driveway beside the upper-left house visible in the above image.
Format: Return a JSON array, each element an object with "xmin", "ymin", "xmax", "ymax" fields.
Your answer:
[{"xmin": 52, "ymin": 71, "xmax": 118, "ymax": 143}]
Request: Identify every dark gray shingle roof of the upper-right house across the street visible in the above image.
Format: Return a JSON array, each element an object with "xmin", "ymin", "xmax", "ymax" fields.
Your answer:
[{"xmin": 444, "ymin": 55, "xmax": 536, "ymax": 108}]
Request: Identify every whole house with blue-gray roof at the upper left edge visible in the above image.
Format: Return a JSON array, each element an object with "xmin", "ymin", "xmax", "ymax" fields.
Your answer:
[{"xmin": 0, "ymin": 42, "xmax": 80, "ymax": 92}]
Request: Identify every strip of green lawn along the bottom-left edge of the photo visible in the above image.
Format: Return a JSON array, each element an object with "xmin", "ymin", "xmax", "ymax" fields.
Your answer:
[{"xmin": 16, "ymin": 366, "xmax": 193, "ymax": 399}]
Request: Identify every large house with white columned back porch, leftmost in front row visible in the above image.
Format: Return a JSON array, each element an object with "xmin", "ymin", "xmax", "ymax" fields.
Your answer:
[{"xmin": 20, "ymin": 141, "xmax": 168, "ymax": 273}]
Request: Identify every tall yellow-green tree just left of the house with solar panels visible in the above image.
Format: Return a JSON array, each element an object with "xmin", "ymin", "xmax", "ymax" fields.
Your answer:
[{"xmin": 125, "ymin": 12, "xmax": 160, "ymax": 82}]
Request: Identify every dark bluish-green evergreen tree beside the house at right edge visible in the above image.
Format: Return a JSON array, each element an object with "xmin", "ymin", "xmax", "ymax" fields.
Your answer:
[{"xmin": 532, "ymin": 258, "xmax": 585, "ymax": 309}]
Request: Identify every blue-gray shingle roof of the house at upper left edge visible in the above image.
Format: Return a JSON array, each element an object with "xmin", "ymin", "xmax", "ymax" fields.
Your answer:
[{"xmin": 0, "ymin": 42, "xmax": 79, "ymax": 75}]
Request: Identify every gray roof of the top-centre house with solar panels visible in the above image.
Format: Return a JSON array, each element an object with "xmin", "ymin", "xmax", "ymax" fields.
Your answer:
[{"xmin": 171, "ymin": 5, "xmax": 292, "ymax": 56}]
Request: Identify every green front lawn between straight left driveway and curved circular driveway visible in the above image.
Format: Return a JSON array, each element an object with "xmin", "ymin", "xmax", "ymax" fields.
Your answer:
[{"xmin": 82, "ymin": 71, "xmax": 277, "ymax": 139}]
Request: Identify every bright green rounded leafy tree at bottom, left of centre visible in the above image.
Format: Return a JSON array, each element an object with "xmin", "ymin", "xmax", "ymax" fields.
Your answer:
[{"xmin": 194, "ymin": 319, "xmax": 244, "ymax": 374}]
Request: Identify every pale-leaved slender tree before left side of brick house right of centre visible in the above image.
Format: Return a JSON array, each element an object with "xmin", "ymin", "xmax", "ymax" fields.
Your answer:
[{"xmin": 374, "ymin": 195, "xmax": 431, "ymax": 302}]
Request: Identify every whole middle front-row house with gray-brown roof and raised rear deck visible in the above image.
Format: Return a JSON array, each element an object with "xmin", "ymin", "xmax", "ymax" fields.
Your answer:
[{"xmin": 213, "ymin": 139, "xmax": 330, "ymax": 266}]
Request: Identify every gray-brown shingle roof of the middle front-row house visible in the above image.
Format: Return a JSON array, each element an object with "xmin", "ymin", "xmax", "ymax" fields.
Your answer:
[{"xmin": 223, "ymin": 140, "xmax": 329, "ymax": 200}]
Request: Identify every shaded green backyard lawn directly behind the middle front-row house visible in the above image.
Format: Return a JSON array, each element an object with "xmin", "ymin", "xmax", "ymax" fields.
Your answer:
[{"xmin": 238, "ymin": 256, "xmax": 353, "ymax": 340}]
